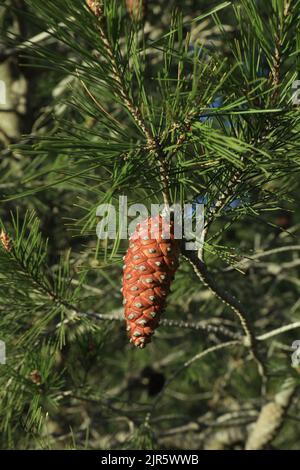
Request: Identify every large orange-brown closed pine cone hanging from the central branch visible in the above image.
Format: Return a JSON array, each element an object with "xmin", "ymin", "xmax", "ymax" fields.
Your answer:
[{"xmin": 122, "ymin": 215, "xmax": 179, "ymax": 348}]
